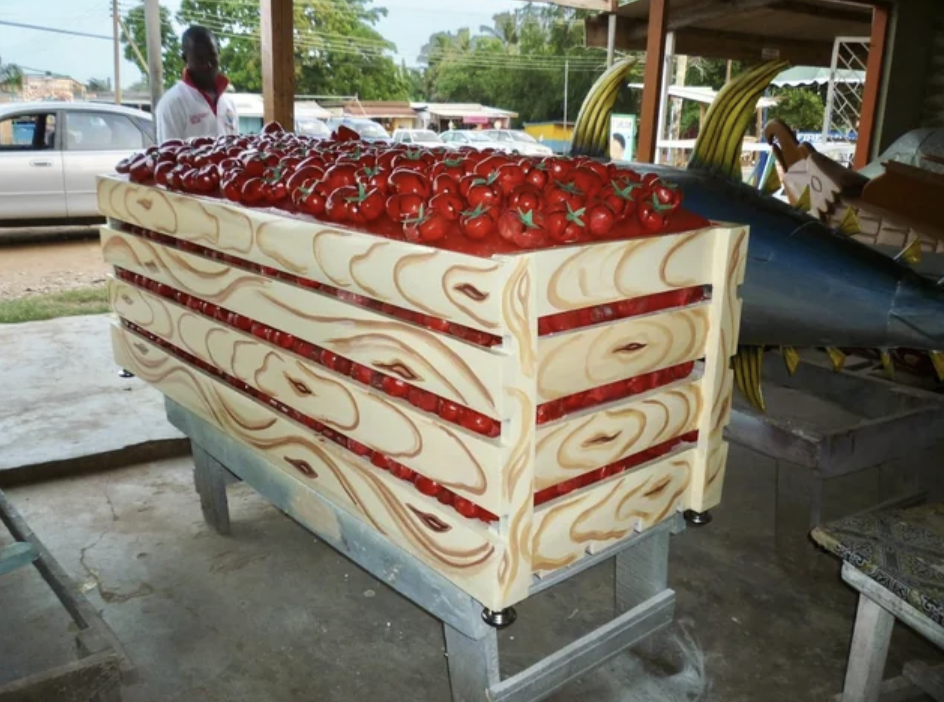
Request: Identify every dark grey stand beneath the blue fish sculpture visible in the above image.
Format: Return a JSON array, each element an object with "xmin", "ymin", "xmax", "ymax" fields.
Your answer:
[{"xmin": 725, "ymin": 353, "xmax": 944, "ymax": 567}]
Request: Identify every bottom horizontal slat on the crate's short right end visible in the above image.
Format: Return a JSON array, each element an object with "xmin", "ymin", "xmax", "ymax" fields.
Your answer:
[{"xmin": 531, "ymin": 449, "xmax": 694, "ymax": 575}]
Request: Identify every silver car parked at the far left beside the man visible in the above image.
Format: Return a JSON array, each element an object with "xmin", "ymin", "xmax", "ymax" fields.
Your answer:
[{"xmin": 0, "ymin": 102, "xmax": 154, "ymax": 226}]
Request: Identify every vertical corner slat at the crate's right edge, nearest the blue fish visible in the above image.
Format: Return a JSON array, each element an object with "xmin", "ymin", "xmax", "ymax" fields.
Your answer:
[{"xmin": 689, "ymin": 228, "xmax": 748, "ymax": 512}]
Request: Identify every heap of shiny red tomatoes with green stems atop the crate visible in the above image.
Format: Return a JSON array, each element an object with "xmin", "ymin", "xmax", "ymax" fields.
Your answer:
[{"xmin": 117, "ymin": 123, "xmax": 681, "ymax": 251}]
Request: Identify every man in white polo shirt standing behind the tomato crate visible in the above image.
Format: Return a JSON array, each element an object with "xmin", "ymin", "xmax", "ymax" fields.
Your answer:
[{"xmin": 155, "ymin": 25, "xmax": 239, "ymax": 142}]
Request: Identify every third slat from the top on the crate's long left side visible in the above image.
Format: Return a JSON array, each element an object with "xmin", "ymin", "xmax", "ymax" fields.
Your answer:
[{"xmin": 109, "ymin": 280, "xmax": 502, "ymax": 514}]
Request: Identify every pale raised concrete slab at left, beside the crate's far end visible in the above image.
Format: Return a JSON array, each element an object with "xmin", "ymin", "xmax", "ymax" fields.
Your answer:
[{"xmin": 0, "ymin": 315, "xmax": 189, "ymax": 485}]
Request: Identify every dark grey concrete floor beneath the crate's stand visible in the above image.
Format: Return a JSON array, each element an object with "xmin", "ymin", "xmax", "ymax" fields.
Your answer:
[{"xmin": 0, "ymin": 447, "xmax": 940, "ymax": 702}]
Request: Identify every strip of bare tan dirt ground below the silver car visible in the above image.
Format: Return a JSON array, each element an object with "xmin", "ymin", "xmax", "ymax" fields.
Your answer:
[{"xmin": 0, "ymin": 238, "xmax": 109, "ymax": 300}]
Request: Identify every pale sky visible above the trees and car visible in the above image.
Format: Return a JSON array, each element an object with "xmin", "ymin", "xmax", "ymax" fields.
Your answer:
[{"xmin": 0, "ymin": 0, "xmax": 521, "ymax": 86}]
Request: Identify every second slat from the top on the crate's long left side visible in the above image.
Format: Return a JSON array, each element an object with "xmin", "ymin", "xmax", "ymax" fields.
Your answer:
[{"xmin": 101, "ymin": 227, "xmax": 503, "ymax": 419}]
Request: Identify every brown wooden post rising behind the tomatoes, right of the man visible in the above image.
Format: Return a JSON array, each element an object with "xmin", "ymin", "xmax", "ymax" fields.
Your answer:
[{"xmin": 260, "ymin": 0, "xmax": 295, "ymax": 131}]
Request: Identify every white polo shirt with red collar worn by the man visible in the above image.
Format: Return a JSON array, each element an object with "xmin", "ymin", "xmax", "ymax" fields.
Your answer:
[{"xmin": 155, "ymin": 70, "xmax": 239, "ymax": 143}]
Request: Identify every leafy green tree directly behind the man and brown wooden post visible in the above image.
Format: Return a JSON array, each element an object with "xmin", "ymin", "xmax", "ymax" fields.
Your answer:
[{"xmin": 177, "ymin": 0, "xmax": 411, "ymax": 100}]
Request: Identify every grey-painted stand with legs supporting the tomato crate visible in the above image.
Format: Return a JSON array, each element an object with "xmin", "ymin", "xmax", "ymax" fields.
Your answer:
[{"xmin": 167, "ymin": 400, "xmax": 684, "ymax": 702}]
